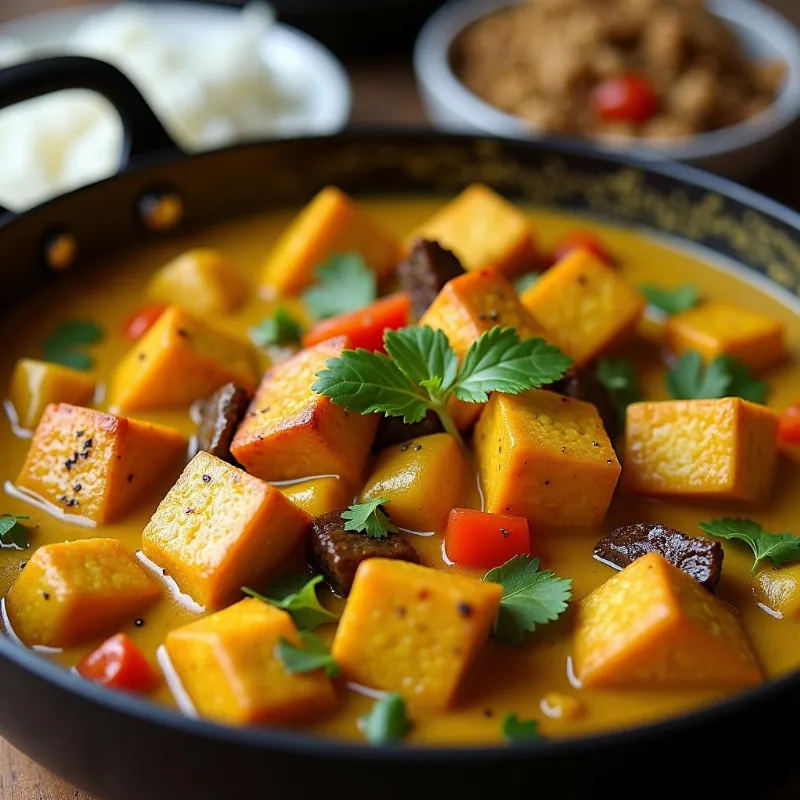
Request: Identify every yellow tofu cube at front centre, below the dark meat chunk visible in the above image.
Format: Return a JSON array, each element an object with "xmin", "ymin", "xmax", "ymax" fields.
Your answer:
[{"xmin": 332, "ymin": 558, "xmax": 503, "ymax": 710}]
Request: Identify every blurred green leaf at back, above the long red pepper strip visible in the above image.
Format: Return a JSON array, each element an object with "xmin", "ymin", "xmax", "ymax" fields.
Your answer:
[{"xmin": 303, "ymin": 253, "xmax": 378, "ymax": 319}]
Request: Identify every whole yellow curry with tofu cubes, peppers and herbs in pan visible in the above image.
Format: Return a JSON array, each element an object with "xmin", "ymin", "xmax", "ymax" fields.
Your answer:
[{"xmin": 0, "ymin": 185, "xmax": 800, "ymax": 745}]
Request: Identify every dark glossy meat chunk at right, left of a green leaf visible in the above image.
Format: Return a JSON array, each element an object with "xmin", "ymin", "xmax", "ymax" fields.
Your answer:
[{"xmin": 594, "ymin": 522, "xmax": 724, "ymax": 592}]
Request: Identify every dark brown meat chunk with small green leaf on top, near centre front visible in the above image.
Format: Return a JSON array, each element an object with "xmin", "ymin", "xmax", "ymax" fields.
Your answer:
[{"xmin": 306, "ymin": 511, "xmax": 419, "ymax": 597}]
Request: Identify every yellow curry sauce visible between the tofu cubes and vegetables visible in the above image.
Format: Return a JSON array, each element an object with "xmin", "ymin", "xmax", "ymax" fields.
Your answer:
[{"xmin": 0, "ymin": 199, "xmax": 800, "ymax": 744}]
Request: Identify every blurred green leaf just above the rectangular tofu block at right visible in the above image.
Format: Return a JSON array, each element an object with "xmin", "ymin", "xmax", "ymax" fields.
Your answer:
[{"xmin": 667, "ymin": 351, "xmax": 767, "ymax": 403}]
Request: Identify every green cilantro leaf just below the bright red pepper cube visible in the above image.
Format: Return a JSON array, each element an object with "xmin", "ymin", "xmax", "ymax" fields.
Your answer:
[{"xmin": 483, "ymin": 555, "xmax": 572, "ymax": 645}]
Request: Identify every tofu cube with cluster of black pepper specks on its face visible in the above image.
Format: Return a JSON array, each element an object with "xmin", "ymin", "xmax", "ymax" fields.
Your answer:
[{"xmin": 16, "ymin": 403, "xmax": 189, "ymax": 522}]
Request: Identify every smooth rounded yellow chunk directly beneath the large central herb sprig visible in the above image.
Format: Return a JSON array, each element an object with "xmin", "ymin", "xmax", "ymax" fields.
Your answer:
[{"xmin": 359, "ymin": 433, "xmax": 466, "ymax": 531}]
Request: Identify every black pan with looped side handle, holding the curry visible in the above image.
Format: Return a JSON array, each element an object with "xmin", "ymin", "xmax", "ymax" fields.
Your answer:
[{"xmin": 0, "ymin": 57, "xmax": 800, "ymax": 800}]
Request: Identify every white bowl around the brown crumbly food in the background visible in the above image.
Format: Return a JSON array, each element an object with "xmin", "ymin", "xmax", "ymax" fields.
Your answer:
[{"xmin": 414, "ymin": 0, "xmax": 800, "ymax": 179}]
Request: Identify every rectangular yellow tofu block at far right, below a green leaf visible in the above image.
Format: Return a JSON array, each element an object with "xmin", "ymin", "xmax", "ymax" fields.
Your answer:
[{"xmin": 622, "ymin": 397, "xmax": 780, "ymax": 503}]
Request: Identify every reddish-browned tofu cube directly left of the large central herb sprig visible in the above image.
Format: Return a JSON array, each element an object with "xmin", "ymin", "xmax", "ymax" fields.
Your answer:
[{"xmin": 231, "ymin": 336, "xmax": 378, "ymax": 486}]
